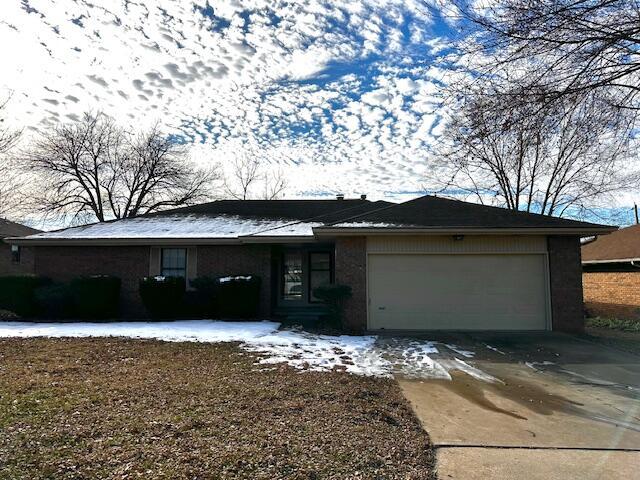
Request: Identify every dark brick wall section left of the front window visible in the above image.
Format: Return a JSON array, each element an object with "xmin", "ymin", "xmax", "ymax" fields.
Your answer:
[{"xmin": 34, "ymin": 246, "xmax": 149, "ymax": 318}]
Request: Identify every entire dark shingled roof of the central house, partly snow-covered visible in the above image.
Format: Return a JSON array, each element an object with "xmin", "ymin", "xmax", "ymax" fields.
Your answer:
[{"xmin": 12, "ymin": 196, "xmax": 616, "ymax": 245}]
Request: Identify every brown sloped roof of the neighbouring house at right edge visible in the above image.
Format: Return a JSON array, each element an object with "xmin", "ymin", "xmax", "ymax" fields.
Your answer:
[{"xmin": 582, "ymin": 225, "xmax": 640, "ymax": 263}]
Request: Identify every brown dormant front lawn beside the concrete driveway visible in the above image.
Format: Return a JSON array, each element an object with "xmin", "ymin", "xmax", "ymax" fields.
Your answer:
[{"xmin": 0, "ymin": 339, "xmax": 434, "ymax": 480}]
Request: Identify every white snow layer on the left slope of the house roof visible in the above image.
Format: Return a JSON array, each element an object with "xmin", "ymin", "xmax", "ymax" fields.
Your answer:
[{"xmin": 22, "ymin": 215, "xmax": 298, "ymax": 240}]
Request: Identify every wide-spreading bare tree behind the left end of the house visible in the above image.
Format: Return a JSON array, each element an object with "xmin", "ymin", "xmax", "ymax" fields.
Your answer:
[{"xmin": 24, "ymin": 114, "xmax": 216, "ymax": 222}]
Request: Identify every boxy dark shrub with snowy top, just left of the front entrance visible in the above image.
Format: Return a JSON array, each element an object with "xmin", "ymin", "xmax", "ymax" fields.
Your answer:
[{"xmin": 217, "ymin": 275, "xmax": 261, "ymax": 319}]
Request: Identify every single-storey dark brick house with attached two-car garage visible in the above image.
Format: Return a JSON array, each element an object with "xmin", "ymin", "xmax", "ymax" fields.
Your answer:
[{"xmin": 8, "ymin": 196, "xmax": 615, "ymax": 331}]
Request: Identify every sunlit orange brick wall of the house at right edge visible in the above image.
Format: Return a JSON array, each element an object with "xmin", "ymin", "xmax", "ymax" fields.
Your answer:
[{"xmin": 582, "ymin": 270, "xmax": 640, "ymax": 320}]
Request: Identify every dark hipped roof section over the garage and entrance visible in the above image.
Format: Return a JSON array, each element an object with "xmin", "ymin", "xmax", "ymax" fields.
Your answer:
[{"xmin": 315, "ymin": 196, "xmax": 617, "ymax": 234}]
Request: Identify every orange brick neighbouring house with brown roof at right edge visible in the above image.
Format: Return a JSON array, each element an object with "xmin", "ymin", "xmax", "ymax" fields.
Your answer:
[{"xmin": 582, "ymin": 225, "xmax": 640, "ymax": 319}]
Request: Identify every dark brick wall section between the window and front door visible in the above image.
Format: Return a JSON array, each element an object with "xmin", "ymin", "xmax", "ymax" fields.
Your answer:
[{"xmin": 197, "ymin": 244, "xmax": 271, "ymax": 318}]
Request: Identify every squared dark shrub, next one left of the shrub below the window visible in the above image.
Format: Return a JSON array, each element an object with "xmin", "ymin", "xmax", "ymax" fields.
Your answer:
[{"xmin": 70, "ymin": 275, "xmax": 122, "ymax": 320}]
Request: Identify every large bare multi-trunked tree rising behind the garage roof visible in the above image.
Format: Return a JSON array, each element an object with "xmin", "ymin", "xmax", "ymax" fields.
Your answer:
[{"xmin": 429, "ymin": 87, "xmax": 637, "ymax": 216}]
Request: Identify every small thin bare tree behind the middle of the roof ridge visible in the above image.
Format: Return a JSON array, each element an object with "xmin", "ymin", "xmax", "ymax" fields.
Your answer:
[{"xmin": 224, "ymin": 154, "xmax": 287, "ymax": 200}]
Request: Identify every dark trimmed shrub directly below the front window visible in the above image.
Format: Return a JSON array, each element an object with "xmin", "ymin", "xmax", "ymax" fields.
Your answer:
[{"xmin": 139, "ymin": 276, "xmax": 186, "ymax": 318}]
